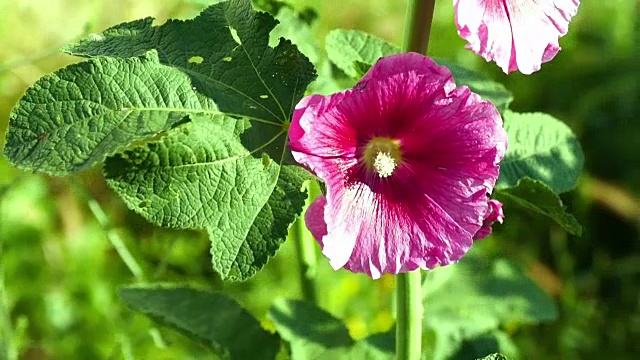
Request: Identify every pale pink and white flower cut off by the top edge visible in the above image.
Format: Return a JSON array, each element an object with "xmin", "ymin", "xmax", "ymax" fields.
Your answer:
[{"xmin": 453, "ymin": 0, "xmax": 580, "ymax": 74}]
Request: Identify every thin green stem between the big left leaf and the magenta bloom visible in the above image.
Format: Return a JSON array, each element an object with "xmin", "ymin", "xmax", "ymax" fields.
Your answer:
[{"xmin": 291, "ymin": 182, "xmax": 320, "ymax": 304}]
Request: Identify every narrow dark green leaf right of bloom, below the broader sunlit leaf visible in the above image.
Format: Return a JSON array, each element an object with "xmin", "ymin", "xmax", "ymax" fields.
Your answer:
[{"xmin": 495, "ymin": 177, "xmax": 582, "ymax": 236}]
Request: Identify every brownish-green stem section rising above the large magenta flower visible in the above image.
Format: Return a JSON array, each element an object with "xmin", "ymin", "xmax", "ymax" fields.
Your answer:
[{"xmin": 402, "ymin": 0, "xmax": 436, "ymax": 54}]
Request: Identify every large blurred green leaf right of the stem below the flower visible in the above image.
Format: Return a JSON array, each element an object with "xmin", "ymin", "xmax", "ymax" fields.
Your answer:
[{"xmin": 423, "ymin": 254, "xmax": 558, "ymax": 359}]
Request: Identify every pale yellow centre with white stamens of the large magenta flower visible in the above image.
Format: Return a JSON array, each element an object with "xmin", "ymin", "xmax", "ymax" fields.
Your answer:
[{"xmin": 364, "ymin": 137, "xmax": 402, "ymax": 178}]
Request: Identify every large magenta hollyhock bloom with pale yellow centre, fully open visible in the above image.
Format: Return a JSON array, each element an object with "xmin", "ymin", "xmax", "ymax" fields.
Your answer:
[{"xmin": 289, "ymin": 53, "xmax": 507, "ymax": 279}]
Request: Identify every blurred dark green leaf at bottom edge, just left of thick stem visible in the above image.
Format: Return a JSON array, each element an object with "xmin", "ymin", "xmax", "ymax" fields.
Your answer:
[{"xmin": 268, "ymin": 299, "xmax": 395, "ymax": 360}]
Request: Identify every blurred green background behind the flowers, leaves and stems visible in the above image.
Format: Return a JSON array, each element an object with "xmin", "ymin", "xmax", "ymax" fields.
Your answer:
[{"xmin": 0, "ymin": 0, "xmax": 640, "ymax": 359}]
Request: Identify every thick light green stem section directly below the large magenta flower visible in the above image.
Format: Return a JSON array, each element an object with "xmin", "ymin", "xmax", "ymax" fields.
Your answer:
[{"xmin": 396, "ymin": 270, "xmax": 422, "ymax": 360}]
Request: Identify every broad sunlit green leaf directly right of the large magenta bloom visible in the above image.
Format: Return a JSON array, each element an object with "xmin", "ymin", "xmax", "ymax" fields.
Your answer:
[{"xmin": 496, "ymin": 111, "xmax": 584, "ymax": 193}]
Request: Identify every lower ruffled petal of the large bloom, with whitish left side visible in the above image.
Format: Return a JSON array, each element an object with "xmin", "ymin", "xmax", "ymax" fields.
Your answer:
[{"xmin": 322, "ymin": 174, "xmax": 473, "ymax": 279}]
